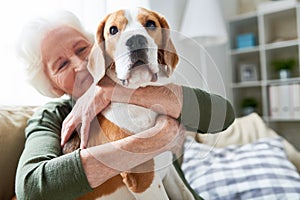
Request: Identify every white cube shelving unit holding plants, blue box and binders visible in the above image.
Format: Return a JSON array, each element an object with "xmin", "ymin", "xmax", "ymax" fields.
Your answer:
[{"xmin": 228, "ymin": 1, "xmax": 300, "ymax": 145}]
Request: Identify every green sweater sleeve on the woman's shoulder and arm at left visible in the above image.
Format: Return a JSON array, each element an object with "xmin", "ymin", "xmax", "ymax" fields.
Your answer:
[{"xmin": 16, "ymin": 100, "xmax": 92, "ymax": 200}]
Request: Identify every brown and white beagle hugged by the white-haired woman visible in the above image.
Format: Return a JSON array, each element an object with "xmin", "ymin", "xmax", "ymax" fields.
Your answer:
[{"xmin": 66, "ymin": 8, "xmax": 194, "ymax": 200}]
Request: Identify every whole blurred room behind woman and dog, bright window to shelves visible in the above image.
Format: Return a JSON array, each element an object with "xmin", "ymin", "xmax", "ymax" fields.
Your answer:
[{"xmin": 0, "ymin": 0, "xmax": 300, "ymax": 148}]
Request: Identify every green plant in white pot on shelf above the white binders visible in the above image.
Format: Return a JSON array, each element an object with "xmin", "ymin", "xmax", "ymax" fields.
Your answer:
[{"xmin": 272, "ymin": 58, "xmax": 296, "ymax": 79}]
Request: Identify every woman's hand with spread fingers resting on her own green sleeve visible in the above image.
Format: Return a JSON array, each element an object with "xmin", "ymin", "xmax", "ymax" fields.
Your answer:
[{"xmin": 61, "ymin": 77, "xmax": 115, "ymax": 148}]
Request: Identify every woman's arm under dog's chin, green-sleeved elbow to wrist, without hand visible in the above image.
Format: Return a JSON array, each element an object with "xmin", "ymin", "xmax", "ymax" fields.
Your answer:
[{"xmin": 111, "ymin": 84, "xmax": 235, "ymax": 133}]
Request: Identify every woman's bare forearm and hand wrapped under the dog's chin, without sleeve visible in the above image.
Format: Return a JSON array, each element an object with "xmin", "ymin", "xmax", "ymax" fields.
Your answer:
[{"xmin": 61, "ymin": 76, "xmax": 182, "ymax": 148}]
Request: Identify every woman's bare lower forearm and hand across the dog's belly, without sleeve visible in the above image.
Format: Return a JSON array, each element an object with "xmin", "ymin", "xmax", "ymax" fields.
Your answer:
[{"xmin": 81, "ymin": 116, "xmax": 184, "ymax": 188}]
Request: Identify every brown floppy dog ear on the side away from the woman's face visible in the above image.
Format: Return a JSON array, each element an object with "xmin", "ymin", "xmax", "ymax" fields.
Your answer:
[{"xmin": 156, "ymin": 13, "xmax": 179, "ymax": 76}]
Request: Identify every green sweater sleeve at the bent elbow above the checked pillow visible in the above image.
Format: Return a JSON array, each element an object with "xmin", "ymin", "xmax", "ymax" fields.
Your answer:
[{"xmin": 179, "ymin": 87, "xmax": 235, "ymax": 133}]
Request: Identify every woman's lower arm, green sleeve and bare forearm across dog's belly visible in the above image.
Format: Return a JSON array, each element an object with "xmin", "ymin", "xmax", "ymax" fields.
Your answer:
[{"xmin": 16, "ymin": 98, "xmax": 183, "ymax": 199}]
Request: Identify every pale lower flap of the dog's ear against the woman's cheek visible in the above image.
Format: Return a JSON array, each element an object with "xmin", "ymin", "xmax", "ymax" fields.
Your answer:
[{"xmin": 87, "ymin": 44, "xmax": 105, "ymax": 83}]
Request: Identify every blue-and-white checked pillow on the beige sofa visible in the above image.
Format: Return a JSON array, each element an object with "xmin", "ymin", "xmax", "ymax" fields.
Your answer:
[{"xmin": 182, "ymin": 137, "xmax": 300, "ymax": 200}]
